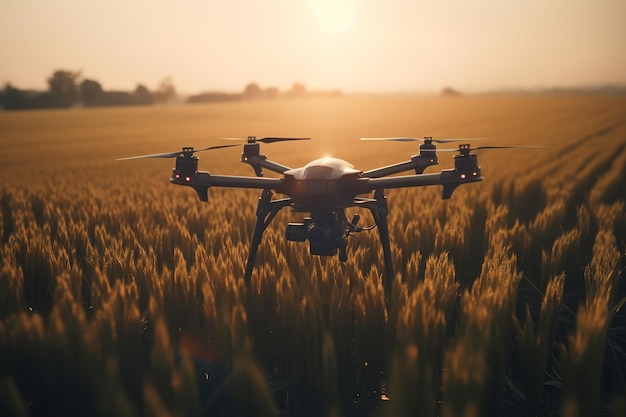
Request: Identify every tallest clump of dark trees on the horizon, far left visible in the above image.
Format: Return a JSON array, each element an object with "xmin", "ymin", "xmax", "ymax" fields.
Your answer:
[{"xmin": 0, "ymin": 70, "xmax": 177, "ymax": 110}]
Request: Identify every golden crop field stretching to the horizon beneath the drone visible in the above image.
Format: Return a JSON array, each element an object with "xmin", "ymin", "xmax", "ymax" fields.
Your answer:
[{"xmin": 0, "ymin": 95, "xmax": 626, "ymax": 417}]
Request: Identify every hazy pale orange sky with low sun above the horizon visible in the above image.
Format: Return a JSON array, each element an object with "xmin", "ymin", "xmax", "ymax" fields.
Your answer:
[{"xmin": 0, "ymin": 0, "xmax": 626, "ymax": 94}]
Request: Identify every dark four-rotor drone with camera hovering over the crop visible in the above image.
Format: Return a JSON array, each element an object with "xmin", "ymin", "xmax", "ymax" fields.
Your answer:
[{"xmin": 118, "ymin": 136, "xmax": 532, "ymax": 294}]
